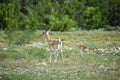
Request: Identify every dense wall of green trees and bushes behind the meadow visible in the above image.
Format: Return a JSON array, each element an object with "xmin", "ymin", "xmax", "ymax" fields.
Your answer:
[{"xmin": 0, "ymin": 0, "xmax": 120, "ymax": 31}]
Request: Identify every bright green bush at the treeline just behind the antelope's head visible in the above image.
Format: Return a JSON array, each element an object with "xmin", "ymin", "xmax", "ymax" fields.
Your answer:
[{"xmin": 50, "ymin": 15, "xmax": 77, "ymax": 31}]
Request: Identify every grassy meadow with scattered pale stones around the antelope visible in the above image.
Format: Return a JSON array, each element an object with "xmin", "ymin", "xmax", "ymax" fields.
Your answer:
[{"xmin": 0, "ymin": 30, "xmax": 120, "ymax": 80}]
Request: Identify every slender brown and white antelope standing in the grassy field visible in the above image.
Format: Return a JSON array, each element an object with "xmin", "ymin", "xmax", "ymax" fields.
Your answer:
[{"xmin": 43, "ymin": 30, "xmax": 63, "ymax": 62}]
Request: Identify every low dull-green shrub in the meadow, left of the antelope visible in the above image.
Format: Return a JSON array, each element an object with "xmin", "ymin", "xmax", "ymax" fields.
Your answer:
[{"xmin": 4, "ymin": 30, "xmax": 34, "ymax": 45}]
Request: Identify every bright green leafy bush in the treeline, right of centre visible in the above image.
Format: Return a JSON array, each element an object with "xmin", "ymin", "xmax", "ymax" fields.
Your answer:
[{"xmin": 83, "ymin": 7, "xmax": 102, "ymax": 29}]
